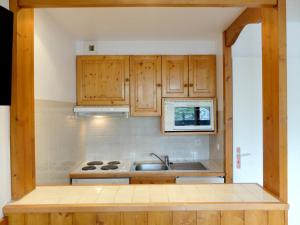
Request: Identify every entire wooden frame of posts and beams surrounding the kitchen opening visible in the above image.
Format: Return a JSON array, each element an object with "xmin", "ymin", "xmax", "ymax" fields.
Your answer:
[{"xmin": 10, "ymin": 0, "xmax": 287, "ymax": 204}]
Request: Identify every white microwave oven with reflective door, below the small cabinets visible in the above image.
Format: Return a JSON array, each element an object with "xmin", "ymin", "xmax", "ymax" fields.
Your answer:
[{"xmin": 163, "ymin": 99, "xmax": 216, "ymax": 132}]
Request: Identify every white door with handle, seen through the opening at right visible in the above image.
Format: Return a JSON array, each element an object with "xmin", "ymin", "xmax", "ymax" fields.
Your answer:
[{"xmin": 233, "ymin": 25, "xmax": 263, "ymax": 184}]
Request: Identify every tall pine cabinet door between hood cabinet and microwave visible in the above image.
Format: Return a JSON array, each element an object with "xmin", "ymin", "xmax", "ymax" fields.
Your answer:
[{"xmin": 130, "ymin": 56, "xmax": 161, "ymax": 116}]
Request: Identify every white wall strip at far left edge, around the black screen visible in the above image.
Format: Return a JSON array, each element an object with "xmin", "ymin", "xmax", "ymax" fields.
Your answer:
[{"xmin": 0, "ymin": 0, "xmax": 11, "ymax": 218}]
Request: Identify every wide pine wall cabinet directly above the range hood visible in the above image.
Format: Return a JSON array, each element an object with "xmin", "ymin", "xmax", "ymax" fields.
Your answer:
[{"xmin": 77, "ymin": 56, "xmax": 129, "ymax": 105}]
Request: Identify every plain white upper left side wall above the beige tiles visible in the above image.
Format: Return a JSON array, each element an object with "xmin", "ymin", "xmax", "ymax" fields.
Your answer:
[{"xmin": 34, "ymin": 9, "xmax": 76, "ymax": 102}]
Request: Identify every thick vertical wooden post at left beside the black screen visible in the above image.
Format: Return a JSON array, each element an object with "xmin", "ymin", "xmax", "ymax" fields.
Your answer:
[{"xmin": 10, "ymin": 0, "xmax": 35, "ymax": 200}]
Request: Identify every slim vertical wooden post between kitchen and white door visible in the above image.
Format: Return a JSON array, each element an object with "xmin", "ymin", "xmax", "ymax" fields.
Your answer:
[{"xmin": 223, "ymin": 32, "xmax": 233, "ymax": 184}]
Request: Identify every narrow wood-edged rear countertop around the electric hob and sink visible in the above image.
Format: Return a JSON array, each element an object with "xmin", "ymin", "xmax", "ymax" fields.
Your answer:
[{"xmin": 69, "ymin": 160, "xmax": 225, "ymax": 179}]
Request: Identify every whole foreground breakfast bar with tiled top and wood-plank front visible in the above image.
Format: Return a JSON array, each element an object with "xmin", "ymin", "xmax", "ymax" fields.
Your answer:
[{"xmin": 4, "ymin": 184, "xmax": 288, "ymax": 225}]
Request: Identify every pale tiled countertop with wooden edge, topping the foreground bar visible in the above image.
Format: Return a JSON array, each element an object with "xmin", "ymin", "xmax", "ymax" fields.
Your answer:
[{"xmin": 4, "ymin": 184, "xmax": 288, "ymax": 215}]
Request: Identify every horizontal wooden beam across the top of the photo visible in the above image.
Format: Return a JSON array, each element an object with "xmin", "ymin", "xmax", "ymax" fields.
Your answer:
[{"xmin": 19, "ymin": 0, "xmax": 277, "ymax": 8}]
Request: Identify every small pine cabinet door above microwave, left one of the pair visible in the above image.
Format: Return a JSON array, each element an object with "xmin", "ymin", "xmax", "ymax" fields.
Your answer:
[{"xmin": 162, "ymin": 56, "xmax": 189, "ymax": 98}]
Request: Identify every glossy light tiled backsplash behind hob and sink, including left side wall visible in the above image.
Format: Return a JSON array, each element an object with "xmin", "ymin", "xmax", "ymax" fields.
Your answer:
[{"xmin": 35, "ymin": 100, "xmax": 210, "ymax": 184}]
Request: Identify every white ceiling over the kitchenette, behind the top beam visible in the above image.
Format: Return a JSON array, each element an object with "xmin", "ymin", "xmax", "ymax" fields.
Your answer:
[{"xmin": 37, "ymin": 8, "xmax": 243, "ymax": 41}]
